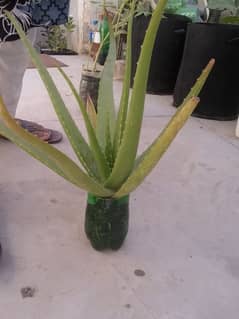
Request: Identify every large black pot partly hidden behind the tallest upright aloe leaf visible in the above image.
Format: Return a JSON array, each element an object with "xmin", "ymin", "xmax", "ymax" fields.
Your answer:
[{"xmin": 131, "ymin": 14, "xmax": 191, "ymax": 94}]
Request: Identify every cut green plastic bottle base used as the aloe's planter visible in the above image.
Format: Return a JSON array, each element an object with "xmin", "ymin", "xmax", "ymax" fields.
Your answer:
[{"xmin": 85, "ymin": 194, "xmax": 129, "ymax": 250}]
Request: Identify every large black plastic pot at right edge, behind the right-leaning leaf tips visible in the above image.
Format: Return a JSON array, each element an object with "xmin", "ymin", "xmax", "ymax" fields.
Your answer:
[{"xmin": 174, "ymin": 23, "xmax": 239, "ymax": 120}]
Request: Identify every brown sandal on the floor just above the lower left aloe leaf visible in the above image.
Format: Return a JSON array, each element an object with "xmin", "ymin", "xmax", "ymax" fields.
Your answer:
[{"xmin": 16, "ymin": 119, "xmax": 62, "ymax": 144}]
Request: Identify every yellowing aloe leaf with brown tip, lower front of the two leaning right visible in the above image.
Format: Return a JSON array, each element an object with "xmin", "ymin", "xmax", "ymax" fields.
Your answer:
[{"xmin": 114, "ymin": 97, "xmax": 199, "ymax": 197}]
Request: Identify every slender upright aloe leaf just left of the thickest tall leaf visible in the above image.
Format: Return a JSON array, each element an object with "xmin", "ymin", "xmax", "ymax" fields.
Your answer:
[{"xmin": 114, "ymin": 2, "xmax": 135, "ymax": 157}]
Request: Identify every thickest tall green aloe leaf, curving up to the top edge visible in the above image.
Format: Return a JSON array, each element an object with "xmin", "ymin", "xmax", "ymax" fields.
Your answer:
[{"xmin": 106, "ymin": 0, "xmax": 167, "ymax": 189}]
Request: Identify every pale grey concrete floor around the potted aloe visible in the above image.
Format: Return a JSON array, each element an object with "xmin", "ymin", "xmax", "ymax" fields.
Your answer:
[{"xmin": 0, "ymin": 57, "xmax": 239, "ymax": 319}]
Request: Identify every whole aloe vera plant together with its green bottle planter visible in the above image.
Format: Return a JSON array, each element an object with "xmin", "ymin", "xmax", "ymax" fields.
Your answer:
[{"xmin": 0, "ymin": 0, "xmax": 214, "ymax": 250}]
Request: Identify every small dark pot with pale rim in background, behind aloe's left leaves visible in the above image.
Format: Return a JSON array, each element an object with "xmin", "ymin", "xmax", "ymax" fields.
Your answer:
[{"xmin": 80, "ymin": 70, "xmax": 100, "ymax": 111}]
